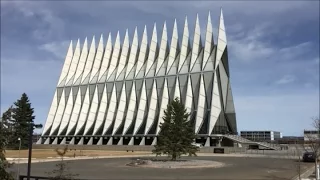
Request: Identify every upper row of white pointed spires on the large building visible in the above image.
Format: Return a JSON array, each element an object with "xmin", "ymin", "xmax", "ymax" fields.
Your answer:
[{"xmin": 58, "ymin": 9, "xmax": 226, "ymax": 87}]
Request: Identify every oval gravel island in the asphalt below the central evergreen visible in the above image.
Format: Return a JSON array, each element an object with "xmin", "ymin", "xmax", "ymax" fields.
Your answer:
[{"xmin": 127, "ymin": 159, "xmax": 226, "ymax": 169}]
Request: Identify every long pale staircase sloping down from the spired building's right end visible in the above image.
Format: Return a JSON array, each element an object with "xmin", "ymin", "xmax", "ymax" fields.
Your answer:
[{"xmin": 223, "ymin": 134, "xmax": 281, "ymax": 150}]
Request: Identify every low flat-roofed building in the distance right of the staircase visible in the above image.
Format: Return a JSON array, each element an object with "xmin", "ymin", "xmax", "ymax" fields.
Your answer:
[{"xmin": 240, "ymin": 131, "xmax": 282, "ymax": 142}]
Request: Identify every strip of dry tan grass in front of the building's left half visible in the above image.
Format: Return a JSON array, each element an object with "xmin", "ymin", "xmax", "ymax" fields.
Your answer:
[{"xmin": 6, "ymin": 149, "xmax": 151, "ymax": 158}]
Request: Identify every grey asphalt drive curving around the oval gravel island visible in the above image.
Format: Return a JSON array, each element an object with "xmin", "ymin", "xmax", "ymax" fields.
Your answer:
[{"xmin": 16, "ymin": 157, "xmax": 313, "ymax": 180}]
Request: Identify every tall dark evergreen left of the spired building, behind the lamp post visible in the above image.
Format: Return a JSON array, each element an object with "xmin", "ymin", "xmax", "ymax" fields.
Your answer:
[{"xmin": 10, "ymin": 93, "xmax": 35, "ymax": 149}]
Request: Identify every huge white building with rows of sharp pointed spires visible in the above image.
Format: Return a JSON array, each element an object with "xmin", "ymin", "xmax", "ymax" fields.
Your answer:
[{"xmin": 38, "ymin": 11, "xmax": 237, "ymax": 145}]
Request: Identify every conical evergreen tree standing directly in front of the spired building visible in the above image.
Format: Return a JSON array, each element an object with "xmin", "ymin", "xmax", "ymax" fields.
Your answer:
[{"xmin": 153, "ymin": 98, "xmax": 198, "ymax": 161}]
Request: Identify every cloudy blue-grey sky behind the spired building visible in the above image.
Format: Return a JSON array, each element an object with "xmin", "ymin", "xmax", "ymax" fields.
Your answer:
[{"xmin": 1, "ymin": 0, "xmax": 319, "ymax": 136}]
